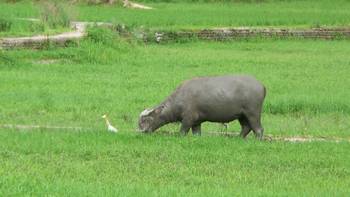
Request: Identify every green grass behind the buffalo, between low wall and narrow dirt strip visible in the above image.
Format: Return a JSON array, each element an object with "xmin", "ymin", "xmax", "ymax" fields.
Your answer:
[{"xmin": 0, "ymin": 36, "xmax": 350, "ymax": 137}]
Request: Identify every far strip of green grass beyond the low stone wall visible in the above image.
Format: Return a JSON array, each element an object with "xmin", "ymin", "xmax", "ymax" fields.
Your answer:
[{"xmin": 0, "ymin": 0, "xmax": 350, "ymax": 30}]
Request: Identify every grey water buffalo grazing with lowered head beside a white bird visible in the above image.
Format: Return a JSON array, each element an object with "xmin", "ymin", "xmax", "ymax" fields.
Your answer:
[{"xmin": 139, "ymin": 75, "xmax": 266, "ymax": 139}]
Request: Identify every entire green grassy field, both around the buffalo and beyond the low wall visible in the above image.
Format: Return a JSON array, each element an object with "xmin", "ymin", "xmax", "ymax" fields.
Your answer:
[{"xmin": 0, "ymin": 1, "xmax": 350, "ymax": 196}]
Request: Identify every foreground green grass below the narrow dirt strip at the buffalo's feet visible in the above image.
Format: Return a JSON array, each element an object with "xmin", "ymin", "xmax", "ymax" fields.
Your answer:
[{"xmin": 0, "ymin": 130, "xmax": 350, "ymax": 196}]
